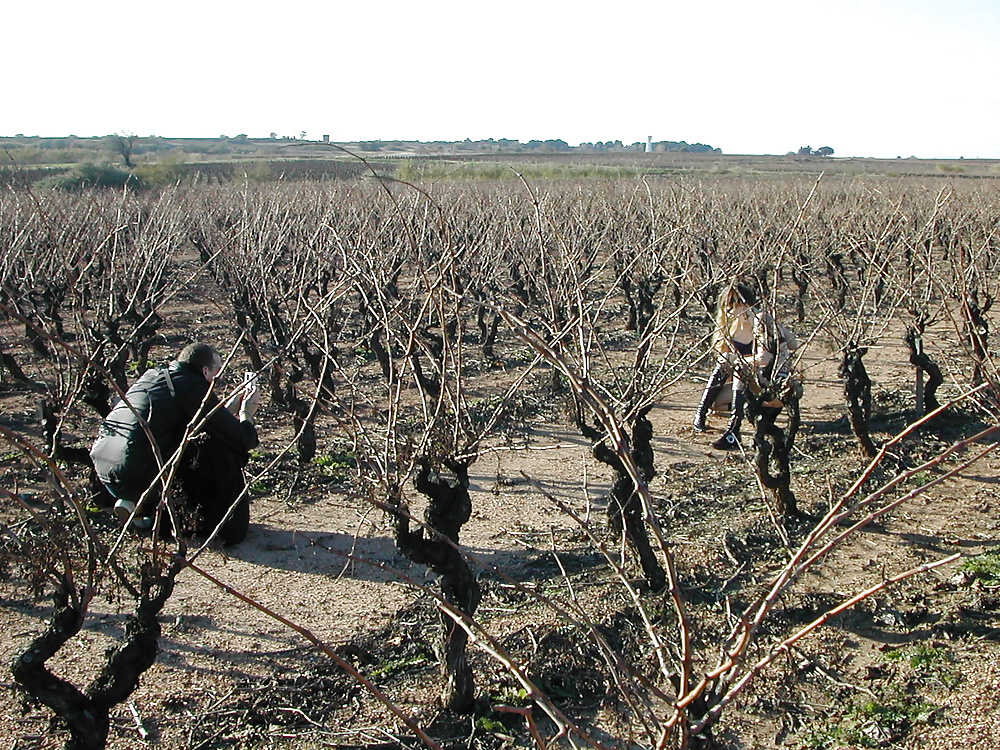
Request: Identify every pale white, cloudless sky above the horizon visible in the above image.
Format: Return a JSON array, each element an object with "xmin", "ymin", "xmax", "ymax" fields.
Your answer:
[{"xmin": 7, "ymin": 0, "xmax": 1000, "ymax": 158}]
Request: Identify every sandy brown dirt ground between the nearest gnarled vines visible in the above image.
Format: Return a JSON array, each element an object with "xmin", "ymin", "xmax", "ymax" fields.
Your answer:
[{"xmin": 0, "ymin": 304, "xmax": 1000, "ymax": 750}]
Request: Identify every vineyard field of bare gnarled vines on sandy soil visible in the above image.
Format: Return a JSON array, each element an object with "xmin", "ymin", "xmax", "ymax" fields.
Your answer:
[{"xmin": 0, "ymin": 170, "xmax": 1000, "ymax": 750}]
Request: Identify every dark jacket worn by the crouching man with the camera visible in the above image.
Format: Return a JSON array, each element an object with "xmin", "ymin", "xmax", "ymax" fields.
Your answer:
[{"xmin": 90, "ymin": 362, "xmax": 257, "ymax": 501}]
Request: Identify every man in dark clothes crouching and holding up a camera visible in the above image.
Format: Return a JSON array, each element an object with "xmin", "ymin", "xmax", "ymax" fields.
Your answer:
[{"xmin": 90, "ymin": 343, "xmax": 260, "ymax": 545}]
